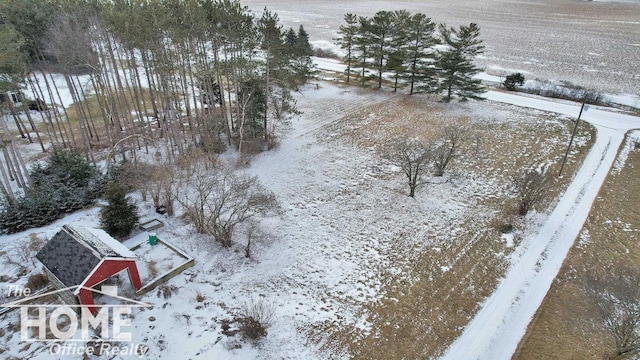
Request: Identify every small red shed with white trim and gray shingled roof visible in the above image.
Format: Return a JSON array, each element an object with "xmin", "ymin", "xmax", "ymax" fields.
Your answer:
[{"xmin": 36, "ymin": 224, "xmax": 142, "ymax": 314}]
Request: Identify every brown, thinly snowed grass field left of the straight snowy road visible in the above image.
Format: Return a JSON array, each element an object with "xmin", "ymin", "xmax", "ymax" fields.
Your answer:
[{"xmin": 311, "ymin": 92, "xmax": 594, "ymax": 359}]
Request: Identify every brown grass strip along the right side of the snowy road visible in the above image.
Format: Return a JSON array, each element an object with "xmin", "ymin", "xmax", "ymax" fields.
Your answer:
[{"xmin": 514, "ymin": 132, "xmax": 640, "ymax": 360}]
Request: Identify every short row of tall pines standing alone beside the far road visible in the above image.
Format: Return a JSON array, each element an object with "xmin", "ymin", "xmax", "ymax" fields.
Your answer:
[{"xmin": 338, "ymin": 10, "xmax": 484, "ymax": 101}]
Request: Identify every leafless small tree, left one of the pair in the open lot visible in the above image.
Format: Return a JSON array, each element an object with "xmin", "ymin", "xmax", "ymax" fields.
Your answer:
[{"xmin": 384, "ymin": 138, "xmax": 433, "ymax": 197}]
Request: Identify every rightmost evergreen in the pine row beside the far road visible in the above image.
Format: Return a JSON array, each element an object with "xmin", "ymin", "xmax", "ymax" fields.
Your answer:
[{"xmin": 436, "ymin": 23, "xmax": 486, "ymax": 102}]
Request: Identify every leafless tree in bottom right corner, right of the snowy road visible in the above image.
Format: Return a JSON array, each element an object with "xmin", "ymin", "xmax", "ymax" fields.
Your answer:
[{"xmin": 584, "ymin": 266, "xmax": 640, "ymax": 360}]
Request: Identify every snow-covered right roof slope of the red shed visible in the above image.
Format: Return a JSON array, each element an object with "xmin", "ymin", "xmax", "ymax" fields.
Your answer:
[{"xmin": 63, "ymin": 224, "xmax": 136, "ymax": 258}]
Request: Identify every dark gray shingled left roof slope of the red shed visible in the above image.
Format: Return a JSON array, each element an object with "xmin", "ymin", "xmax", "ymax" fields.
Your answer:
[{"xmin": 36, "ymin": 230, "xmax": 100, "ymax": 286}]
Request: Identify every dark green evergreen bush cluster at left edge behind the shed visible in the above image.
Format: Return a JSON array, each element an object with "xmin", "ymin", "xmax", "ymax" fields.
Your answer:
[{"xmin": 0, "ymin": 151, "xmax": 105, "ymax": 233}]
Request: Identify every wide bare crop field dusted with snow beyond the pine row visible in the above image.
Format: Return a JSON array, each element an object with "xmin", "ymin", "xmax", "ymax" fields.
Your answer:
[{"xmin": 242, "ymin": 0, "xmax": 640, "ymax": 94}]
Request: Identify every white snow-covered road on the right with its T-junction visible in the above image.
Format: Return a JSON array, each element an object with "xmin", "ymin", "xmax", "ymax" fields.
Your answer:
[{"xmin": 442, "ymin": 91, "xmax": 640, "ymax": 360}]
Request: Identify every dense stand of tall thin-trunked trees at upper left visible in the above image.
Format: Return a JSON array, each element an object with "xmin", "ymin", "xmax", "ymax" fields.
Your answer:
[{"xmin": 0, "ymin": 0, "xmax": 313, "ymax": 201}]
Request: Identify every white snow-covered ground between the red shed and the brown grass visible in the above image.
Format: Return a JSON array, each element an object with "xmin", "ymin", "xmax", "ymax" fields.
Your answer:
[{"xmin": 0, "ymin": 84, "xmax": 432, "ymax": 359}]
